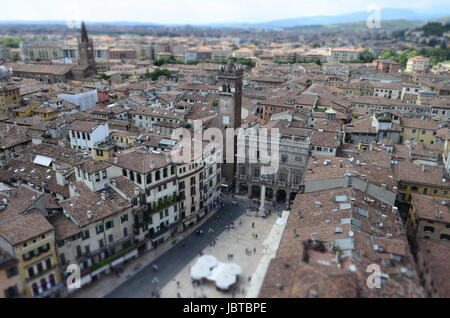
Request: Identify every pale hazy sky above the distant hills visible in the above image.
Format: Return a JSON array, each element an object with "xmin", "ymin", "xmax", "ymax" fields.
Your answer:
[{"xmin": 0, "ymin": 0, "xmax": 449, "ymax": 24}]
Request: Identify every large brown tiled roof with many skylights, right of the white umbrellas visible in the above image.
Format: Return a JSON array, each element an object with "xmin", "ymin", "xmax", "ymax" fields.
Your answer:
[{"xmin": 260, "ymin": 188, "xmax": 424, "ymax": 297}]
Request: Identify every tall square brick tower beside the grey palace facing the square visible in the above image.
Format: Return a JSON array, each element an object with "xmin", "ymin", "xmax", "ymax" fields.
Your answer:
[{"xmin": 218, "ymin": 62, "xmax": 244, "ymax": 188}]
